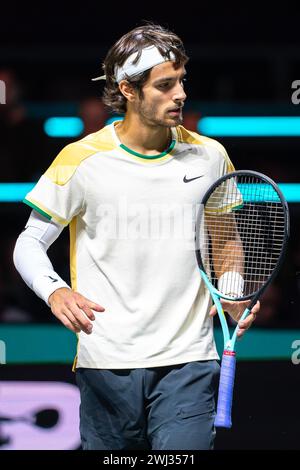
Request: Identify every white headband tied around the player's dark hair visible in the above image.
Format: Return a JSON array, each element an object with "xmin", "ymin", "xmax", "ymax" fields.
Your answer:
[{"xmin": 92, "ymin": 46, "xmax": 175, "ymax": 83}]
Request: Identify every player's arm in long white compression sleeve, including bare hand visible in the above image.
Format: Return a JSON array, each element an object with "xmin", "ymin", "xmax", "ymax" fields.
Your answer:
[{"xmin": 13, "ymin": 211, "xmax": 104, "ymax": 334}]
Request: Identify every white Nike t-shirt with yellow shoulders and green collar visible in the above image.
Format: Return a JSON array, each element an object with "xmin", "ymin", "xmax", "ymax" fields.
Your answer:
[{"xmin": 24, "ymin": 123, "xmax": 234, "ymax": 369}]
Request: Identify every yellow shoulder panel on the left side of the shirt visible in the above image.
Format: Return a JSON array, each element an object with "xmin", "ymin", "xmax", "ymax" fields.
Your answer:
[{"xmin": 45, "ymin": 126, "xmax": 116, "ymax": 186}]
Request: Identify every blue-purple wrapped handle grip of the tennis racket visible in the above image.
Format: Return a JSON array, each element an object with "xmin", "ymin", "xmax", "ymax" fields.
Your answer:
[{"xmin": 215, "ymin": 350, "xmax": 236, "ymax": 428}]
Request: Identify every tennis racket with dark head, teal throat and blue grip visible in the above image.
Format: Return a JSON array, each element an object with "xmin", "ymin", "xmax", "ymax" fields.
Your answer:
[{"xmin": 196, "ymin": 171, "xmax": 289, "ymax": 428}]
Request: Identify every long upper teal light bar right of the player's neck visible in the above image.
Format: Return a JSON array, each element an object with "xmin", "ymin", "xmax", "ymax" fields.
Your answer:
[{"xmin": 197, "ymin": 116, "xmax": 300, "ymax": 137}]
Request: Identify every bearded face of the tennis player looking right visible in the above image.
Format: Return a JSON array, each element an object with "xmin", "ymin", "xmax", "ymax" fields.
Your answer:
[{"xmin": 135, "ymin": 61, "xmax": 186, "ymax": 127}]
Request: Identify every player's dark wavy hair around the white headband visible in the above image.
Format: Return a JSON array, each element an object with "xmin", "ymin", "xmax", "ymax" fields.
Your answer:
[{"xmin": 103, "ymin": 23, "xmax": 188, "ymax": 114}]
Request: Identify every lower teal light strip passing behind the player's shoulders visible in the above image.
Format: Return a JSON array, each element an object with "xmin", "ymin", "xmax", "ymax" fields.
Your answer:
[{"xmin": 0, "ymin": 183, "xmax": 300, "ymax": 202}]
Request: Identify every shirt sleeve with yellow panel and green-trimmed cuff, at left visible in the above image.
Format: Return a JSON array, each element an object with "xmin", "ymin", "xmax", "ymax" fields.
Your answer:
[{"xmin": 23, "ymin": 144, "xmax": 84, "ymax": 225}]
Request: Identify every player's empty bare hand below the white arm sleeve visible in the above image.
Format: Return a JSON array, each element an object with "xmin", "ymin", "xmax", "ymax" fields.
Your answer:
[{"xmin": 48, "ymin": 287, "xmax": 105, "ymax": 335}]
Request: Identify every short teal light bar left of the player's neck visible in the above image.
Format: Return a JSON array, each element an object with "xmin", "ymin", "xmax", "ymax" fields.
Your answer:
[{"xmin": 44, "ymin": 117, "xmax": 84, "ymax": 137}]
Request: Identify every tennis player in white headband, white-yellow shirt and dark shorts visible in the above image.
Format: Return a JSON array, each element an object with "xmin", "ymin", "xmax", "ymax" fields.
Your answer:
[{"xmin": 14, "ymin": 24, "xmax": 259, "ymax": 450}]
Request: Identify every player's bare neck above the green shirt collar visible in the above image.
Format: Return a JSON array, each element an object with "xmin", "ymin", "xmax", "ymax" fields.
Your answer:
[{"xmin": 115, "ymin": 116, "xmax": 172, "ymax": 155}]
